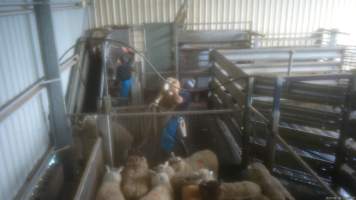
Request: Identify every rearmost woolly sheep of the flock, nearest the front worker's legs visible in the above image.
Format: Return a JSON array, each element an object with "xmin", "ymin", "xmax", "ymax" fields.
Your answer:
[{"xmin": 169, "ymin": 150, "xmax": 219, "ymax": 177}]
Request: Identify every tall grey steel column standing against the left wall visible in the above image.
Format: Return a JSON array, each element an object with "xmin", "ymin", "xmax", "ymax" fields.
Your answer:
[{"xmin": 34, "ymin": 0, "xmax": 72, "ymax": 149}]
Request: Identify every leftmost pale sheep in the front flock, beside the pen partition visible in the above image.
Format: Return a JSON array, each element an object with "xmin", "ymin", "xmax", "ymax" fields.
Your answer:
[{"xmin": 96, "ymin": 167, "xmax": 125, "ymax": 200}]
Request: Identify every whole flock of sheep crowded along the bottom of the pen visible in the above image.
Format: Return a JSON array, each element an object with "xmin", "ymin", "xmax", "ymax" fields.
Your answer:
[{"xmin": 96, "ymin": 150, "xmax": 294, "ymax": 200}]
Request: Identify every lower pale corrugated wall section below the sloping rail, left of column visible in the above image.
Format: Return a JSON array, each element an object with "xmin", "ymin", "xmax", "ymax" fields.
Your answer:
[{"xmin": 0, "ymin": 91, "xmax": 49, "ymax": 199}]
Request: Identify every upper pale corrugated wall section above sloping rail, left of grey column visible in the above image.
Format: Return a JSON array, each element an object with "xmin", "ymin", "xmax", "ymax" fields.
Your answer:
[{"xmin": 0, "ymin": 15, "xmax": 43, "ymax": 105}]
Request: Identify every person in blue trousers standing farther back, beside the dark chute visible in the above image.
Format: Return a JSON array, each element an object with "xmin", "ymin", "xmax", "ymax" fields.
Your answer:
[{"xmin": 116, "ymin": 47, "xmax": 134, "ymax": 101}]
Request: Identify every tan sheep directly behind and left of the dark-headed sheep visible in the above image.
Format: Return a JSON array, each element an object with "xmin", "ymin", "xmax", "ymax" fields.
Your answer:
[{"xmin": 171, "ymin": 169, "xmax": 215, "ymax": 199}]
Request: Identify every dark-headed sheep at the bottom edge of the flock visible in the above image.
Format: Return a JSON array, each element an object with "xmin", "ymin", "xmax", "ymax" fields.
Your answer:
[{"xmin": 199, "ymin": 181, "xmax": 264, "ymax": 200}]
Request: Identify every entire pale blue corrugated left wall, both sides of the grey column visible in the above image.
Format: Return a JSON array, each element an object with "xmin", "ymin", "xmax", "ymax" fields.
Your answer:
[{"xmin": 0, "ymin": 0, "xmax": 88, "ymax": 200}]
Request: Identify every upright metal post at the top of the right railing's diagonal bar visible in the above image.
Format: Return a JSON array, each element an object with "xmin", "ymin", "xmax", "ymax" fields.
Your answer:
[{"xmin": 265, "ymin": 77, "xmax": 284, "ymax": 170}]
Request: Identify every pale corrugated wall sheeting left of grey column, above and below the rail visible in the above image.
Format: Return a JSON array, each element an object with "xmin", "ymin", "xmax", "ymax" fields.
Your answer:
[{"xmin": 0, "ymin": 14, "xmax": 49, "ymax": 199}]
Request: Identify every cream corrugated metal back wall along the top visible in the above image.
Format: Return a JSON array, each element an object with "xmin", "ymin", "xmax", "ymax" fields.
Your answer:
[{"xmin": 90, "ymin": 0, "xmax": 356, "ymax": 39}]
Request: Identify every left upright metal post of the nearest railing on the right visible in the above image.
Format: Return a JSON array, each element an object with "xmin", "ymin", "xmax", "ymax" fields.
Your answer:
[{"xmin": 241, "ymin": 77, "xmax": 254, "ymax": 167}]
